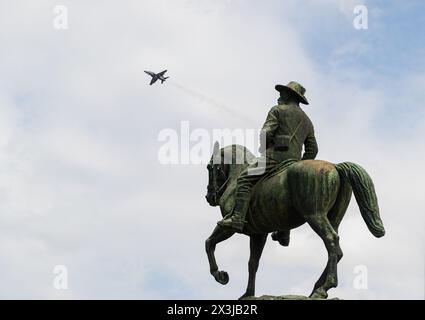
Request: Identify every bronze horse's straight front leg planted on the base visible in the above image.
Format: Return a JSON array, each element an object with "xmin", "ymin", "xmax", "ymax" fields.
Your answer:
[{"xmin": 239, "ymin": 234, "xmax": 267, "ymax": 299}]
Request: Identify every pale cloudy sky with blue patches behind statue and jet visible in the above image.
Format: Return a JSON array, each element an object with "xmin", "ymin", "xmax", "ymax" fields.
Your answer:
[{"xmin": 0, "ymin": 0, "xmax": 425, "ymax": 299}]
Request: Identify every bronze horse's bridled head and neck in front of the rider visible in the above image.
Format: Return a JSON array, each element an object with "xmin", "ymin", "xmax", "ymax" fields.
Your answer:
[{"xmin": 205, "ymin": 142, "xmax": 254, "ymax": 207}]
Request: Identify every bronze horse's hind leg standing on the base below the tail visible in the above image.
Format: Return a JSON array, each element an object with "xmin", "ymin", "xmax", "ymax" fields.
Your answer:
[{"xmin": 306, "ymin": 214, "xmax": 342, "ymax": 299}]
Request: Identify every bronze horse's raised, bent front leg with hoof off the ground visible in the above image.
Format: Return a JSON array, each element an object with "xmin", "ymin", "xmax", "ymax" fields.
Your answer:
[{"xmin": 205, "ymin": 226, "xmax": 235, "ymax": 284}]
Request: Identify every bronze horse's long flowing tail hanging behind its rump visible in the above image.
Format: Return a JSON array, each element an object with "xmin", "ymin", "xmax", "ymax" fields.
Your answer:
[{"xmin": 335, "ymin": 162, "xmax": 385, "ymax": 238}]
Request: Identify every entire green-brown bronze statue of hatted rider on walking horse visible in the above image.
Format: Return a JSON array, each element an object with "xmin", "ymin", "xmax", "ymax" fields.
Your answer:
[{"xmin": 205, "ymin": 82, "xmax": 385, "ymax": 298}]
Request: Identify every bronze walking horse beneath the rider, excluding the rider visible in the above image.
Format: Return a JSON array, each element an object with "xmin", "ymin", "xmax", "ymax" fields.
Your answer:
[{"xmin": 205, "ymin": 142, "xmax": 385, "ymax": 299}]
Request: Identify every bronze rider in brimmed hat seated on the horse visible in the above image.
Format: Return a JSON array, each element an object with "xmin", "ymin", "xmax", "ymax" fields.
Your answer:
[{"xmin": 218, "ymin": 81, "xmax": 318, "ymax": 245}]
